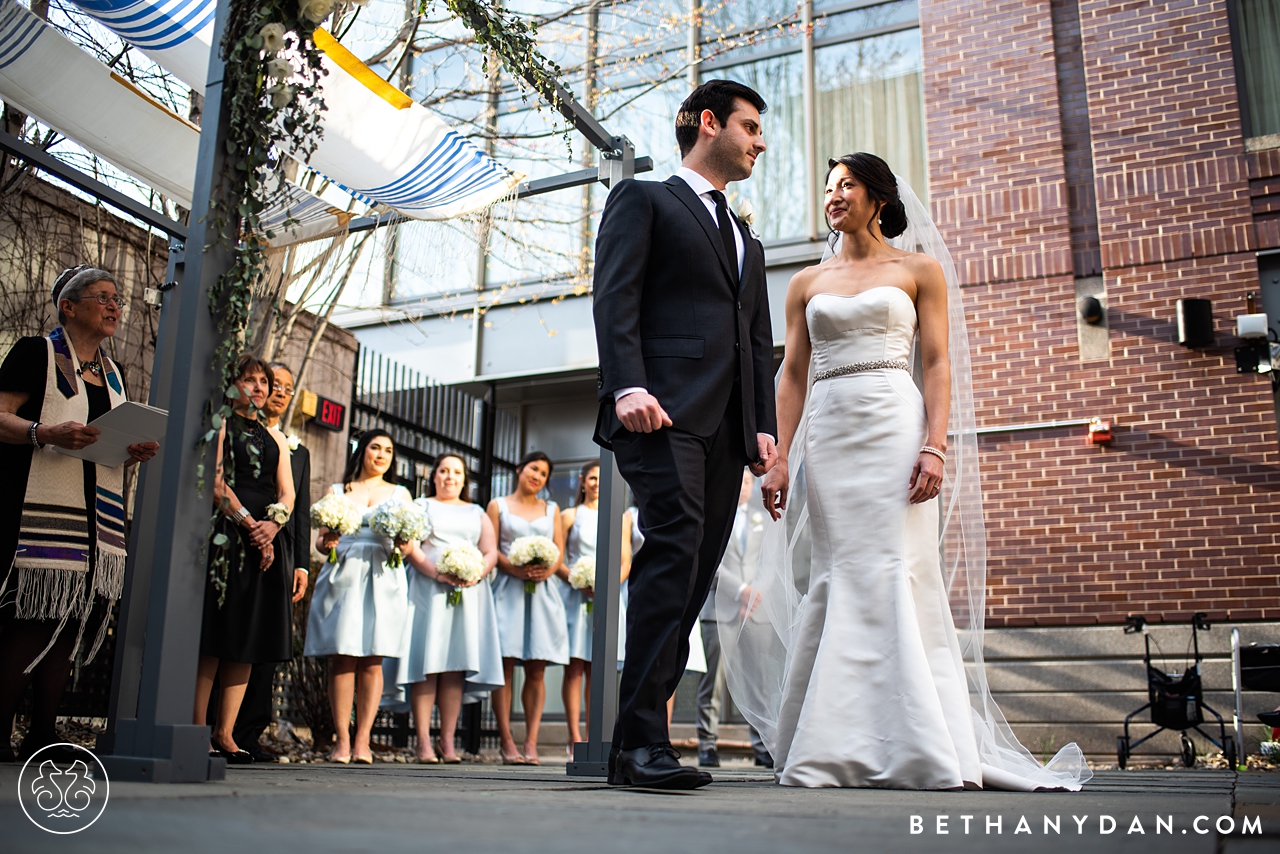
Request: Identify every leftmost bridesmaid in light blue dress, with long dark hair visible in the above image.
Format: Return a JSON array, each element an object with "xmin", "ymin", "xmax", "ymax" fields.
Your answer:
[{"xmin": 302, "ymin": 430, "xmax": 417, "ymax": 764}]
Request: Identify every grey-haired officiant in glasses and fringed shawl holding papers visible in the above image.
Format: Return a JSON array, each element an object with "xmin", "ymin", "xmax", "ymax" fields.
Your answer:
[{"xmin": 0, "ymin": 265, "xmax": 160, "ymax": 761}]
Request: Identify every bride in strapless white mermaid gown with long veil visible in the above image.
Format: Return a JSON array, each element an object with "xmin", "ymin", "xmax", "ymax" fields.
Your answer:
[{"xmin": 717, "ymin": 154, "xmax": 1089, "ymax": 790}]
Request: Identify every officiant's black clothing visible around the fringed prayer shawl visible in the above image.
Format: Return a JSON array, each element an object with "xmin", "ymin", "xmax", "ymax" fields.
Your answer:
[{"xmin": 0, "ymin": 338, "xmax": 111, "ymax": 620}]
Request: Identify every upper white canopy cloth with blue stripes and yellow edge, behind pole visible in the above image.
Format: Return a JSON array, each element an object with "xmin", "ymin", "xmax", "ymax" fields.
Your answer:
[{"xmin": 73, "ymin": 0, "xmax": 524, "ymax": 219}]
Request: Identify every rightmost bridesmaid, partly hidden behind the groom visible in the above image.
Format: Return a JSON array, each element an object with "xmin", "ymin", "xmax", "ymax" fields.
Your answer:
[{"xmin": 556, "ymin": 460, "xmax": 600, "ymax": 757}]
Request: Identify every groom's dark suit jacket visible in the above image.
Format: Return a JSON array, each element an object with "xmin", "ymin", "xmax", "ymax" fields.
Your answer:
[{"xmin": 594, "ymin": 177, "xmax": 777, "ymax": 460}]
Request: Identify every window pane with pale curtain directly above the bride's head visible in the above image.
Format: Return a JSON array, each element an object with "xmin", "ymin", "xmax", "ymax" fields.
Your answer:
[{"xmin": 814, "ymin": 29, "xmax": 928, "ymax": 204}]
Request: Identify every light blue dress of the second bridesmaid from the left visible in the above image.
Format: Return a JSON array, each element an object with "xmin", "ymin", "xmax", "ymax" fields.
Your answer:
[{"xmin": 393, "ymin": 498, "xmax": 503, "ymax": 703}]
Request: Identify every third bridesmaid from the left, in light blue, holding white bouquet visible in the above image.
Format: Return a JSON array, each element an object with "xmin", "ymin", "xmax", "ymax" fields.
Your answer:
[{"xmin": 485, "ymin": 451, "xmax": 568, "ymax": 764}]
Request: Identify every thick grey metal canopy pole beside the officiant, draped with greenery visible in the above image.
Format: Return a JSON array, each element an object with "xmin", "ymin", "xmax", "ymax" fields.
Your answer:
[{"xmin": 102, "ymin": 0, "xmax": 238, "ymax": 782}]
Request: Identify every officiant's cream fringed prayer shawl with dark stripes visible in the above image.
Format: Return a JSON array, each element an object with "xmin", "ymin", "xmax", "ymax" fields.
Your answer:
[{"xmin": 0, "ymin": 329, "xmax": 125, "ymax": 672}]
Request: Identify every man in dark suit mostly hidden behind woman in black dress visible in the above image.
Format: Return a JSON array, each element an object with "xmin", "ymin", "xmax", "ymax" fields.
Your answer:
[{"xmin": 232, "ymin": 362, "xmax": 311, "ymax": 762}]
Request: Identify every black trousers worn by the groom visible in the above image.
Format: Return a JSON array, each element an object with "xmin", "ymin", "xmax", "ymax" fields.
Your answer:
[{"xmin": 613, "ymin": 389, "xmax": 748, "ymax": 750}]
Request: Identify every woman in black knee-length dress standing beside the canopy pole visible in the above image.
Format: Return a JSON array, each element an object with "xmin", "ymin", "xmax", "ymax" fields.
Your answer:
[{"xmin": 195, "ymin": 356, "xmax": 293, "ymax": 763}]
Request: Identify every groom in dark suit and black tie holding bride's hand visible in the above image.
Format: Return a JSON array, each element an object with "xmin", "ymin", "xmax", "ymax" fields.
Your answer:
[{"xmin": 594, "ymin": 81, "xmax": 777, "ymax": 789}]
